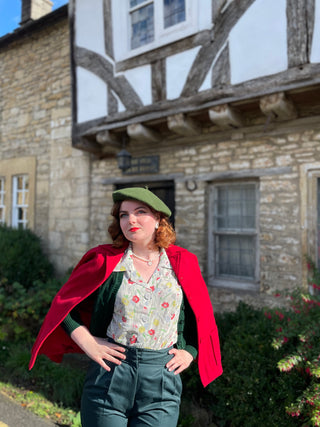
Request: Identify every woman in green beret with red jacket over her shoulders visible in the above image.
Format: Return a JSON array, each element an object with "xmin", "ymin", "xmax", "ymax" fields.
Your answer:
[{"xmin": 30, "ymin": 188, "xmax": 222, "ymax": 427}]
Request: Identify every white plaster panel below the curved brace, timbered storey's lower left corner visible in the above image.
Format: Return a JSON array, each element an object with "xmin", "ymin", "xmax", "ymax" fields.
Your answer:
[{"xmin": 76, "ymin": 67, "xmax": 108, "ymax": 123}]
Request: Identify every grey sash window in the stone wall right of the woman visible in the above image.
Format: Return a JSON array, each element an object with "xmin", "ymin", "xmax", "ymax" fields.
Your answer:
[{"xmin": 209, "ymin": 182, "xmax": 258, "ymax": 289}]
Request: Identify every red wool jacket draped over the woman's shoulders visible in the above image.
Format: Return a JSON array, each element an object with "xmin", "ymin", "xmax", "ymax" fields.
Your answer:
[{"xmin": 29, "ymin": 245, "xmax": 222, "ymax": 387}]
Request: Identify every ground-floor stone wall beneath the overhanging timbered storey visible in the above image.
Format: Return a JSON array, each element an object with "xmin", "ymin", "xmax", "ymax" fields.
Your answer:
[{"xmin": 91, "ymin": 123, "xmax": 320, "ymax": 310}]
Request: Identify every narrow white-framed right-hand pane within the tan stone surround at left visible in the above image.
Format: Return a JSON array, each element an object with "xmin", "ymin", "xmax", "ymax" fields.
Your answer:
[{"xmin": 12, "ymin": 174, "xmax": 29, "ymax": 228}]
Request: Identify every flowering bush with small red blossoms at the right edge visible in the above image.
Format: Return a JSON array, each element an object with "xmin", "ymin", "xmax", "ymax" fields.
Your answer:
[{"xmin": 265, "ymin": 259, "xmax": 320, "ymax": 426}]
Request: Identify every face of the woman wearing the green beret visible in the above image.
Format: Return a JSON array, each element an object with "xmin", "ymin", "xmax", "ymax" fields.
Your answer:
[{"xmin": 119, "ymin": 200, "xmax": 159, "ymax": 244}]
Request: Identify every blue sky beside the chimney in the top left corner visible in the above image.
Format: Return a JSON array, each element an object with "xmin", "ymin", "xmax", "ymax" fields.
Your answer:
[{"xmin": 0, "ymin": 0, "xmax": 68, "ymax": 37}]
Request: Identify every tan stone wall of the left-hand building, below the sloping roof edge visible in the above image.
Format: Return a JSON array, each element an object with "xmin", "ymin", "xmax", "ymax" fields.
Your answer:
[{"xmin": 0, "ymin": 16, "xmax": 90, "ymax": 272}]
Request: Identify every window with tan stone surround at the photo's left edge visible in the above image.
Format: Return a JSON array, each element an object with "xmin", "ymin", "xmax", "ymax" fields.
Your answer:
[{"xmin": 0, "ymin": 157, "xmax": 36, "ymax": 229}]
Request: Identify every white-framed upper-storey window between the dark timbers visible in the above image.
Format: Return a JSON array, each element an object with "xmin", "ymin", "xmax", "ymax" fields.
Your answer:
[{"xmin": 112, "ymin": 0, "xmax": 212, "ymax": 61}]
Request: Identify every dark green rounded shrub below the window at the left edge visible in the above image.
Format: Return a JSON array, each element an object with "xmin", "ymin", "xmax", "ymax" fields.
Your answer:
[{"xmin": 0, "ymin": 226, "xmax": 53, "ymax": 288}]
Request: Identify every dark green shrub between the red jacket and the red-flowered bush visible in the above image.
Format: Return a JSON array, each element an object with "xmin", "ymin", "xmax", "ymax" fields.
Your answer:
[{"xmin": 183, "ymin": 303, "xmax": 303, "ymax": 427}]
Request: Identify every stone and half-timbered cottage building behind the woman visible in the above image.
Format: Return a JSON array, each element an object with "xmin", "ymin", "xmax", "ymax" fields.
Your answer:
[{"xmin": 0, "ymin": 0, "xmax": 320, "ymax": 309}]
